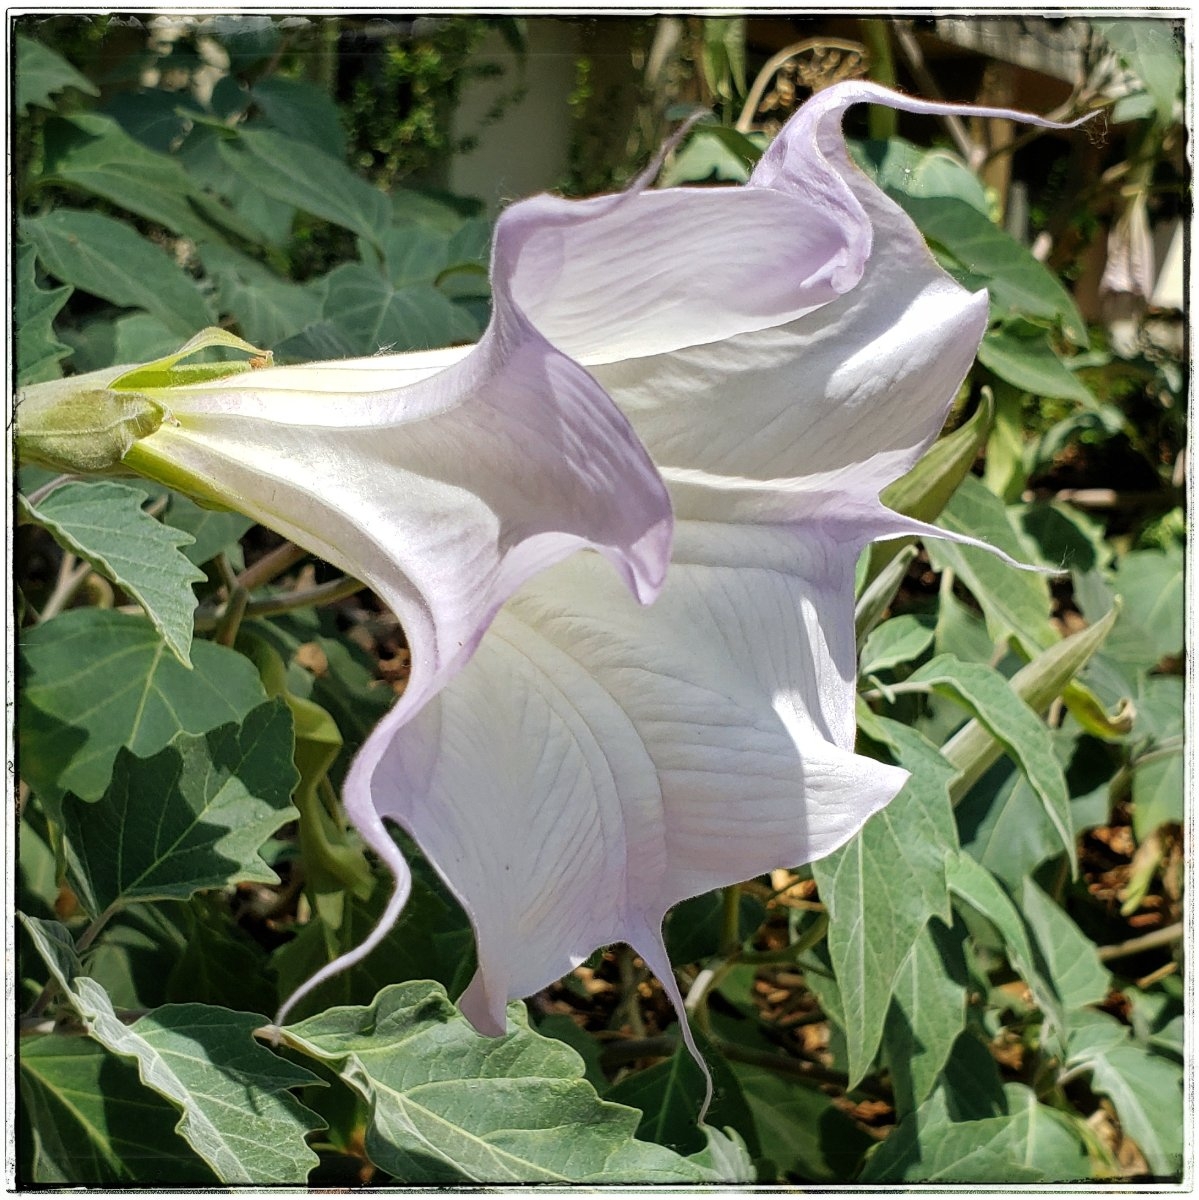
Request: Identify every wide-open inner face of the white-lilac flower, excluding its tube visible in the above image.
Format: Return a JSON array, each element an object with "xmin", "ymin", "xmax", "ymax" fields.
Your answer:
[{"xmin": 304, "ymin": 84, "xmax": 1075, "ymax": 1080}]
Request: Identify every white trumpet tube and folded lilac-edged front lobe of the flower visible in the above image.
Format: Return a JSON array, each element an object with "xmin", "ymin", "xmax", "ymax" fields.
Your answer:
[{"xmin": 126, "ymin": 205, "xmax": 671, "ymax": 712}]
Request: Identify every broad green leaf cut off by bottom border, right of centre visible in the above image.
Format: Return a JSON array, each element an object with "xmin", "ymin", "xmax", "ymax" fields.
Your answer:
[{"xmin": 859, "ymin": 1084, "xmax": 1091, "ymax": 1187}]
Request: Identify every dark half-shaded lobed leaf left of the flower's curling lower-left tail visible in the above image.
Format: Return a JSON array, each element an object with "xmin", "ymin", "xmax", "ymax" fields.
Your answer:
[{"xmin": 62, "ymin": 701, "xmax": 295, "ymax": 917}]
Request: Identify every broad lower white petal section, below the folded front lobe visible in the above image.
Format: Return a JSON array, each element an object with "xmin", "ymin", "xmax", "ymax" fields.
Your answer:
[{"xmin": 346, "ymin": 523, "xmax": 906, "ymax": 1032}]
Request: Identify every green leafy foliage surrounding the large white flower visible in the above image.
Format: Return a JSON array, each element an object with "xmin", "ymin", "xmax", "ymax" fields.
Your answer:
[{"xmin": 16, "ymin": 17, "xmax": 1186, "ymax": 1186}]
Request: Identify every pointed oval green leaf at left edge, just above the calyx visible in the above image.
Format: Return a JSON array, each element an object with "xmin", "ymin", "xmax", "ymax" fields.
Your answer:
[{"xmin": 20, "ymin": 209, "xmax": 211, "ymax": 337}]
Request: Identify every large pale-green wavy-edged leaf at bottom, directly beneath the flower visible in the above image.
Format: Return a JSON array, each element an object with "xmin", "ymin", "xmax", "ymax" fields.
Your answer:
[{"xmin": 281, "ymin": 983, "xmax": 744, "ymax": 1187}]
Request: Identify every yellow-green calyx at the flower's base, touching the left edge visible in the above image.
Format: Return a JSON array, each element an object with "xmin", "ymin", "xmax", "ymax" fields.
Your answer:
[{"xmin": 16, "ymin": 328, "xmax": 268, "ymax": 474}]
